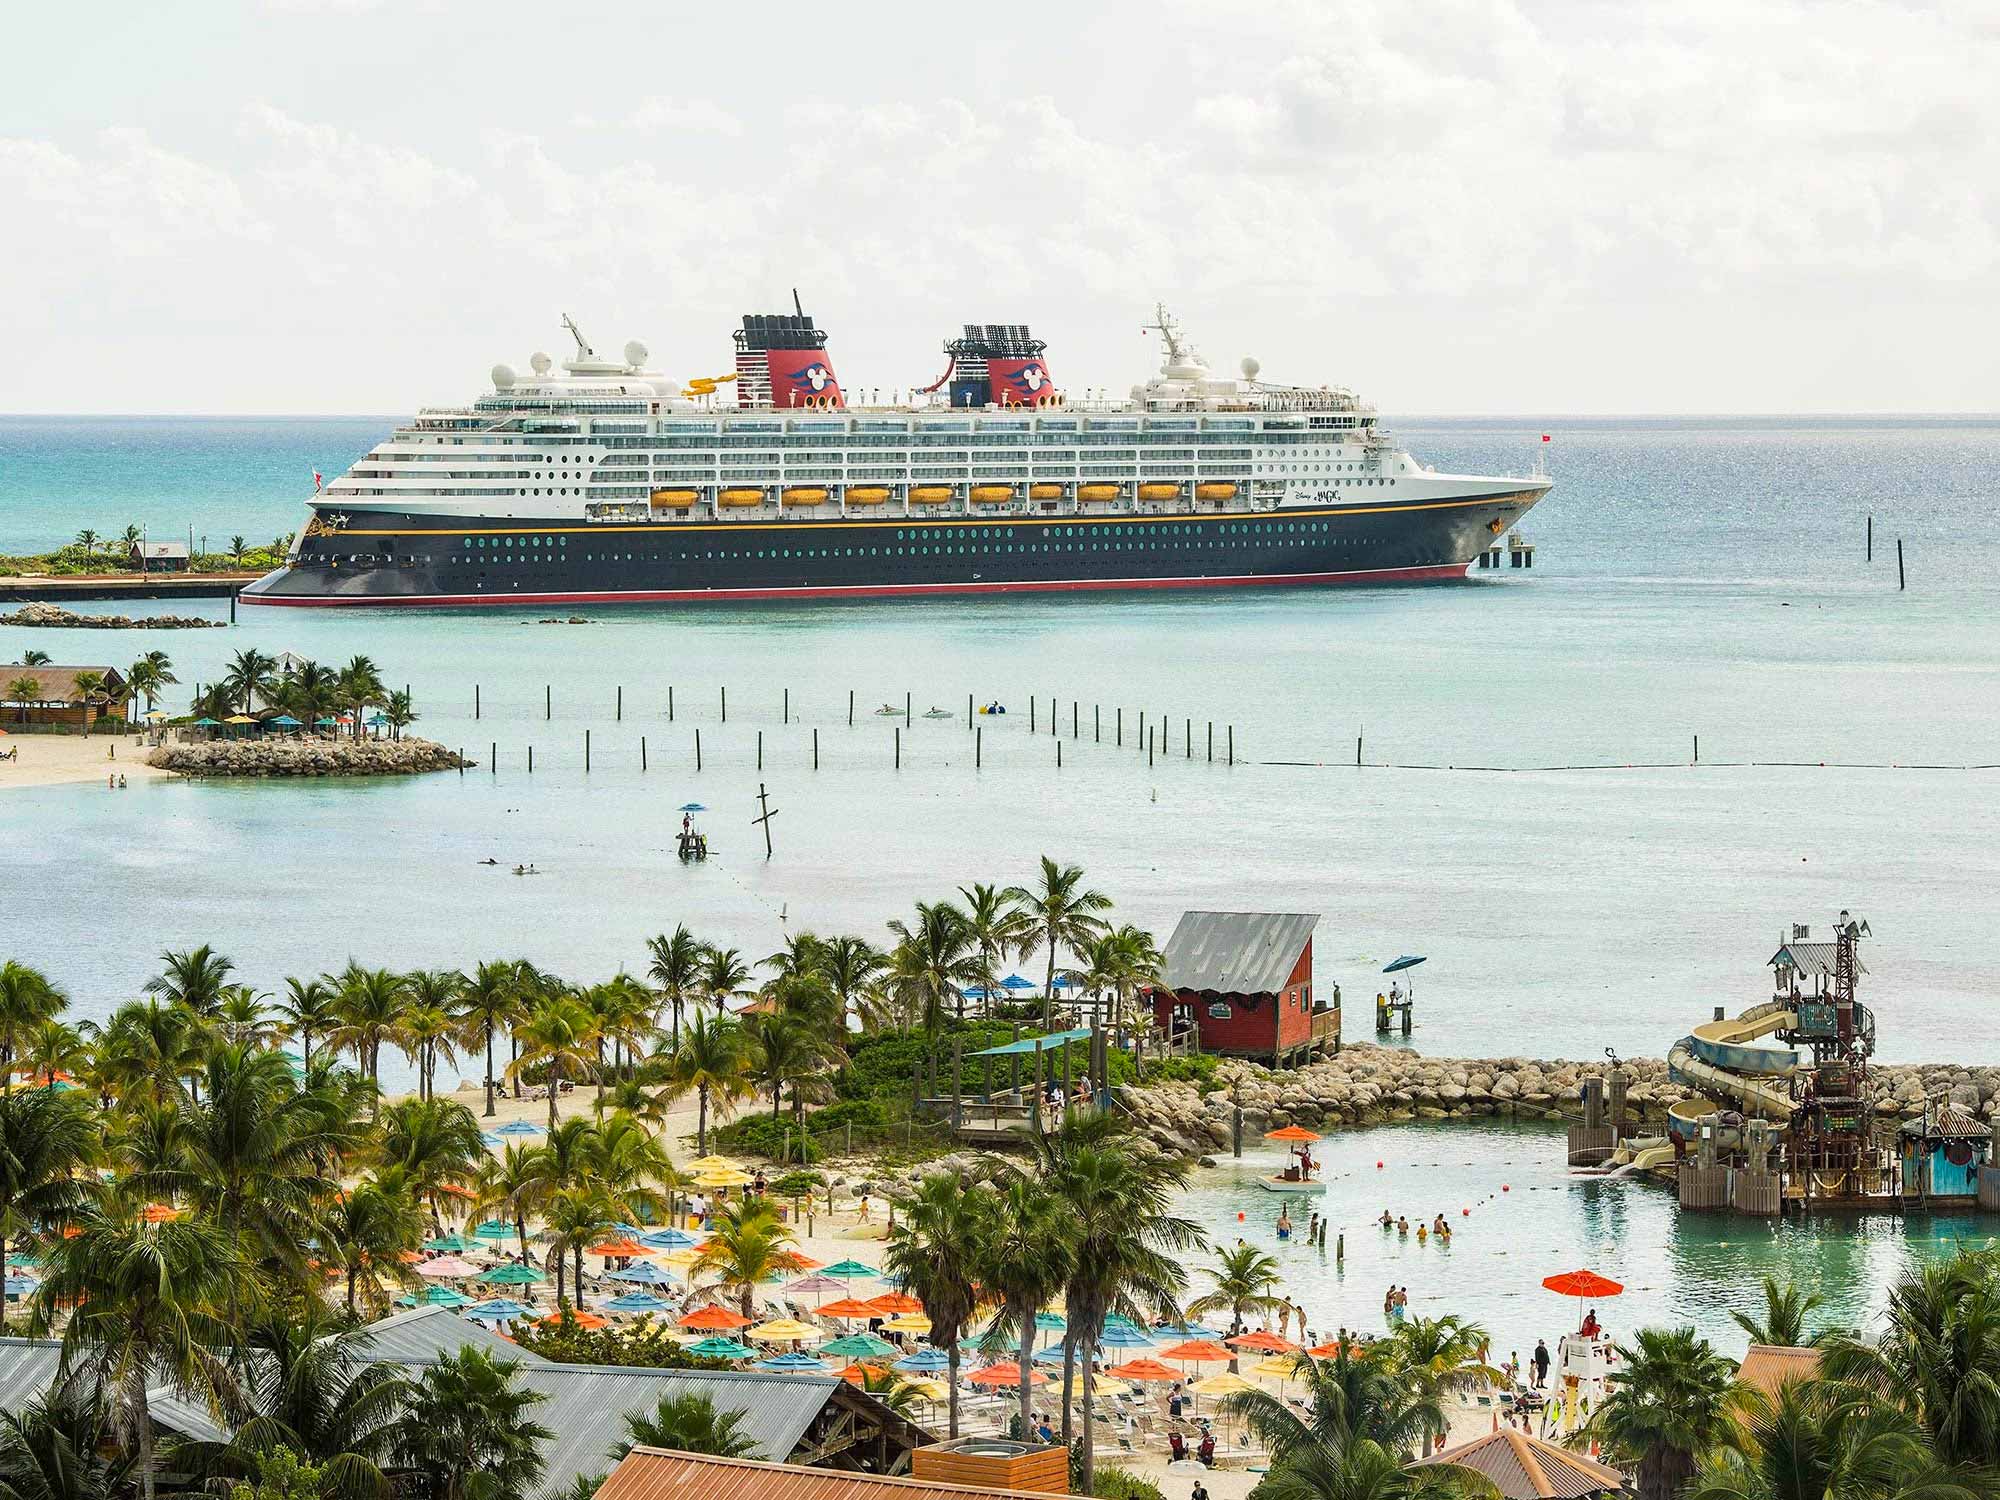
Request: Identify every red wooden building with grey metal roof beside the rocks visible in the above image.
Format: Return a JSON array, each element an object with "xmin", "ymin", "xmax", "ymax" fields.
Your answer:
[{"xmin": 1152, "ymin": 912, "xmax": 1340, "ymax": 1068}]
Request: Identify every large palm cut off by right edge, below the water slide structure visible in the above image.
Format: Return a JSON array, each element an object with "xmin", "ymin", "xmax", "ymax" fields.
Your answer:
[{"xmin": 1820, "ymin": 1250, "xmax": 2000, "ymax": 1468}]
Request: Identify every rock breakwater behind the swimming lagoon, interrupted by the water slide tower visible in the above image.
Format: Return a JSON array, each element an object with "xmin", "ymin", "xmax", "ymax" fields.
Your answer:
[{"xmin": 1118, "ymin": 1042, "xmax": 2000, "ymax": 1156}]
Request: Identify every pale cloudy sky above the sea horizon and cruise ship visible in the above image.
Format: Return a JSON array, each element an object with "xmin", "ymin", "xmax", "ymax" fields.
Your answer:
[{"xmin": 0, "ymin": 0, "xmax": 2000, "ymax": 414}]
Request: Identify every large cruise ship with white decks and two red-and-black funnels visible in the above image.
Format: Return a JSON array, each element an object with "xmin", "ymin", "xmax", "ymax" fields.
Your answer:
[{"xmin": 242, "ymin": 294, "xmax": 1550, "ymax": 606}]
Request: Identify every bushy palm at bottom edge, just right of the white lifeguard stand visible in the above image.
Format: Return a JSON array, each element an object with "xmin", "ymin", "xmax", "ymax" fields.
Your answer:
[{"xmin": 1584, "ymin": 1326, "xmax": 1734, "ymax": 1500}]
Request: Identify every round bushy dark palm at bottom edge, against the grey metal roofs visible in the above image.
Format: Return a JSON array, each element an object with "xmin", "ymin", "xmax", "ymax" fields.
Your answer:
[{"xmin": 392, "ymin": 1348, "xmax": 556, "ymax": 1500}]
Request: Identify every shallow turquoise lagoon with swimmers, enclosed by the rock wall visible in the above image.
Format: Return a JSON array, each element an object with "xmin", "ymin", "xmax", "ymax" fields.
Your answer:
[{"xmin": 1182, "ymin": 1122, "xmax": 2000, "ymax": 1362}]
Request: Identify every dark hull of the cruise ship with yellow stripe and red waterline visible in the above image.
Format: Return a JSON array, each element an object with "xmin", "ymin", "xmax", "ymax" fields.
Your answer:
[{"xmin": 242, "ymin": 494, "xmax": 1546, "ymax": 608}]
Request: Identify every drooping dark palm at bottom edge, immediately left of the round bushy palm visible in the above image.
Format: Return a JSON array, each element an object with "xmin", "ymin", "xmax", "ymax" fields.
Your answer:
[{"xmin": 170, "ymin": 1298, "xmax": 410, "ymax": 1500}]
